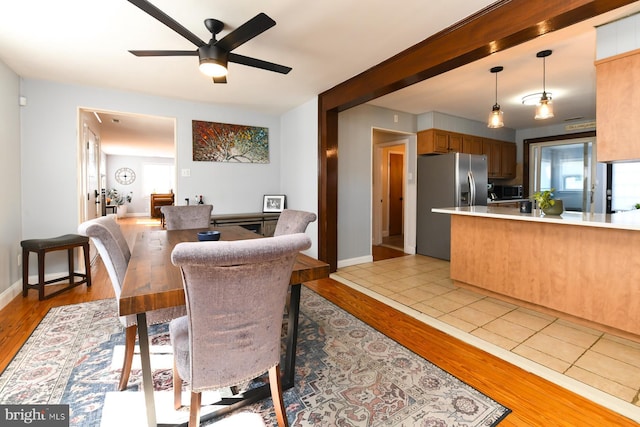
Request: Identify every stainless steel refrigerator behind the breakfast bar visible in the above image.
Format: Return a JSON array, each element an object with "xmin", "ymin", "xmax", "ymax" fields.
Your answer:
[{"xmin": 416, "ymin": 153, "xmax": 488, "ymax": 260}]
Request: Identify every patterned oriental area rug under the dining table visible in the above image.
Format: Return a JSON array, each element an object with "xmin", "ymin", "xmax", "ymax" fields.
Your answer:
[{"xmin": 0, "ymin": 286, "xmax": 510, "ymax": 427}]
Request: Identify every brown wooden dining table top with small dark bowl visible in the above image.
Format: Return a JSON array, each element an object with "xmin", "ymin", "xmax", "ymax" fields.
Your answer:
[{"xmin": 119, "ymin": 226, "xmax": 329, "ymax": 316}]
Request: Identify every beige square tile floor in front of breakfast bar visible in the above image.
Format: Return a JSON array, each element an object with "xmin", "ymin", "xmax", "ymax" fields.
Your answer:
[{"xmin": 332, "ymin": 255, "xmax": 640, "ymax": 418}]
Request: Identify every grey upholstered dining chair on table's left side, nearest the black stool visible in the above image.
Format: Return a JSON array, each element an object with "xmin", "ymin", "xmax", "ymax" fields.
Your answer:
[{"xmin": 78, "ymin": 216, "xmax": 186, "ymax": 390}]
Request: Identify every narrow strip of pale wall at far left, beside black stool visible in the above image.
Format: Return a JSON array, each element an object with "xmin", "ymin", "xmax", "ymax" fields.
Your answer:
[{"xmin": 0, "ymin": 61, "xmax": 22, "ymax": 300}]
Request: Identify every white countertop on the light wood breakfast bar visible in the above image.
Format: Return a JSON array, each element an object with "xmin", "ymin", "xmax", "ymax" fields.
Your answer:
[{"xmin": 432, "ymin": 205, "xmax": 640, "ymax": 231}]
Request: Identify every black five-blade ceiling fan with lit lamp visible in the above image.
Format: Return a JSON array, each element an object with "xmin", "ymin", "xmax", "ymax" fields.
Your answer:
[{"xmin": 129, "ymin": 0, "xmax": 291, "ymax": 83}]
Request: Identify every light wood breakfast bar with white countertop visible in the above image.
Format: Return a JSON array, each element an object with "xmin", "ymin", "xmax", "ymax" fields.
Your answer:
[{"xmin": 433, "ymin": 206, "xmax": 640, "ymax": 335}]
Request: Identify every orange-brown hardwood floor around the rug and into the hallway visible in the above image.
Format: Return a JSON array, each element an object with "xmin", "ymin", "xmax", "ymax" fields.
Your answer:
[{"xmin": 0, "ymin": 218, "xmax": 637, "ymax": 427}]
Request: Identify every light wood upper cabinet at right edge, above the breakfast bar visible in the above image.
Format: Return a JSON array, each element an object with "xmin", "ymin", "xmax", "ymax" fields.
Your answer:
[{"xmin": 596, "ymin": 49, "xmax": 640, "ymax": 162}]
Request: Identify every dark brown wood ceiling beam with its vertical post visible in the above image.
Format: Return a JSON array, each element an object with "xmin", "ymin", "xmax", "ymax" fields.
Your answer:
[{"xmin": 318, "ymin": 0, "xmax": 633, "ymax": 271}]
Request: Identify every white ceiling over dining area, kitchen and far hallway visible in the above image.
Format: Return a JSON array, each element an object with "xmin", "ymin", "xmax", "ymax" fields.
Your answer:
[{"xmin": 0, "ymin": 0, "xmax": 640, "ymax": 155}]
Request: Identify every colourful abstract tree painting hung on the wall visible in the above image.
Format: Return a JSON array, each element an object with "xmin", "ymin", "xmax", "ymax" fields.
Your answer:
[{"xmin": 192, "ymin": 120, "xmax": 269, "ymax": 163}]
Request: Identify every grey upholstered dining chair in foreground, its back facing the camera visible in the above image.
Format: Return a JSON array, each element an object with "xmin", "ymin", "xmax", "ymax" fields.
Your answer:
[{"xmin": 169, "ymin": 233, "xmax": 311, "ymax": 427}]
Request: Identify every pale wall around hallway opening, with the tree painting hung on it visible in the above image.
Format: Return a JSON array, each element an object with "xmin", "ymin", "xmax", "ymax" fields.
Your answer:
[{"xmin": 19, "ymin": 79, "xmax": 317, "ymax": 272}]
